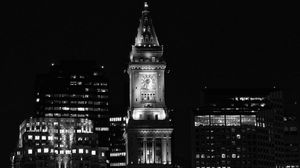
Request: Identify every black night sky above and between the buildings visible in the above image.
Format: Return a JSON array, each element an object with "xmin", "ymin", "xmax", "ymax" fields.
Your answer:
[{"xmin": 0, "ymin": 0, "xmax": 300, "ymax": 167}]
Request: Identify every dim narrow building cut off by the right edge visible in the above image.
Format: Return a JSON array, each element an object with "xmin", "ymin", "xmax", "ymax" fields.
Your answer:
[{"xmin": 284, "ymin": 114, "xmax": 300, "ymax": 168}]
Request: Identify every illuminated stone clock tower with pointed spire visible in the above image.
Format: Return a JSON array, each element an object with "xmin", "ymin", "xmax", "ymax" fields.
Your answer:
[{"xmin": 125, "ymin": 3, "xmax": 173, "ymax": 167}]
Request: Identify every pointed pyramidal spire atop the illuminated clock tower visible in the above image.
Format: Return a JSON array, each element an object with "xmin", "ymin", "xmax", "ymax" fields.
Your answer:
[{"xmin": 135, "ymin": 2, "xmax": 159, "ymax": 46}]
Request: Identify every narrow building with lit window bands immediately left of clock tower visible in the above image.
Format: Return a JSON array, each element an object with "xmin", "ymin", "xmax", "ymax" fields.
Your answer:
[{"xmin": 109, "ymin": 115, "xmax": 127, "ymax": 168}]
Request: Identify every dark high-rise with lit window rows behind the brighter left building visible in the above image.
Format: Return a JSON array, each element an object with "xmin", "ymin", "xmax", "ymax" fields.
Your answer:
[{"xmin": 35, "ymin": 60, "xmax": 109, "ymax": 154}]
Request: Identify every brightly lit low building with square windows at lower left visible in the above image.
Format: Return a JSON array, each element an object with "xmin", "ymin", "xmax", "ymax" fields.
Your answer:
[{"xmin": 11, "ymin": 117, "xmax": 107, "ymax": 168}]
